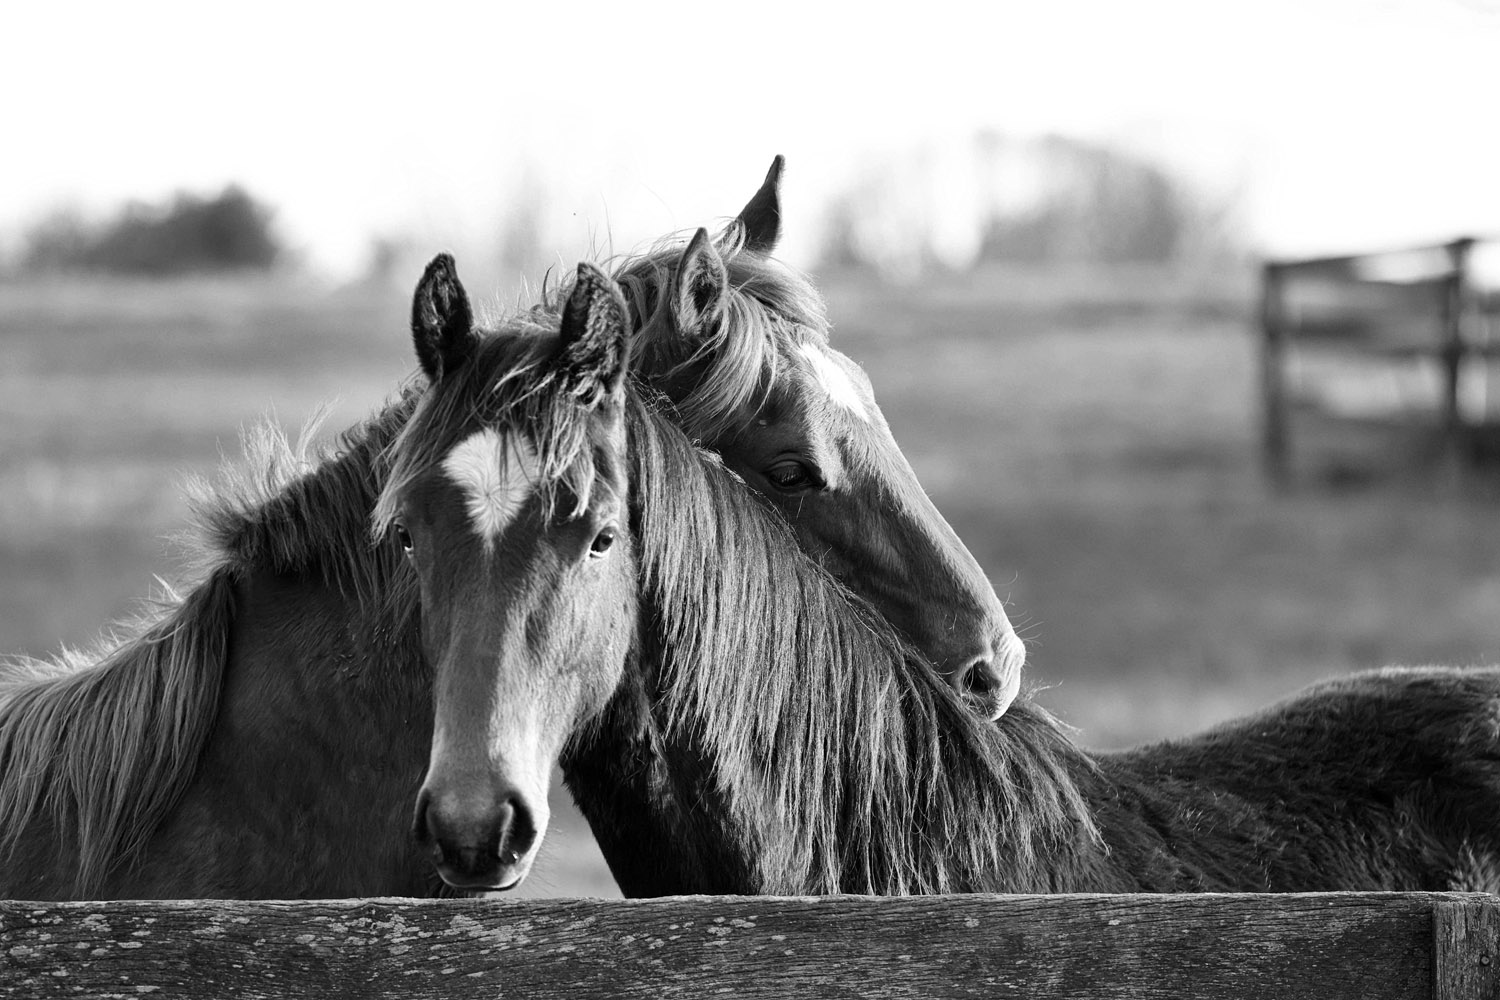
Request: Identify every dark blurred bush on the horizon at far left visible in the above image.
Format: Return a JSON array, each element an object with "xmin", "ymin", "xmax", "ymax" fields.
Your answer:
[{"xmin": 21, "ymin": 184, "xmax": 284, "ymax": 277}]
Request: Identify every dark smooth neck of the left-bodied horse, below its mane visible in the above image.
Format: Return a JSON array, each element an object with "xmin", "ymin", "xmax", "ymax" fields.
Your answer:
[{"xmin": 123, "ymin": 573, "xmax": 431, "ymax": 898}]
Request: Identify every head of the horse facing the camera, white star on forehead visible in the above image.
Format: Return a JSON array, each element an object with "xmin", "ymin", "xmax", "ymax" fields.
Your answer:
[{"xmin": 377, "ymin": 255, "xmax": 636, "ymax": 889}]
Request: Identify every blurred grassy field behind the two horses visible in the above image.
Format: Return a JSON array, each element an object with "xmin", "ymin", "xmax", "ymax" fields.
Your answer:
[{"xmin": 0, "ymin": 265, "xmax": 1500, "ymax": 894}]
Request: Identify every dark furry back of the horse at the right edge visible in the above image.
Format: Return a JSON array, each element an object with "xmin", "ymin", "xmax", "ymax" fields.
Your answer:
[{"xmin": 1100, "ymin": 667, "xmax": 1500, "ymax": 892}]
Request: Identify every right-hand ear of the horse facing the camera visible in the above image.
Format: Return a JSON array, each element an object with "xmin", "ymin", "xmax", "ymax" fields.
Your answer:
[{"xmin": 554, "ymin": 262, "xmax": 630, "ymax": 406}]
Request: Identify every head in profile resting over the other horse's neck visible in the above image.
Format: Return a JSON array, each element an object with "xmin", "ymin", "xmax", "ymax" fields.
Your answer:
[{"xmin": 626, "ymin": 157, "xmax": 1026, "ymax": 718}]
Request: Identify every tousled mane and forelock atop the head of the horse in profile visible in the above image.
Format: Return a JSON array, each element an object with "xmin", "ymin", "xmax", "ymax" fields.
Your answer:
[{"xmin": 612, "ymin": 232, "xmax": 828, "ymax": 441}]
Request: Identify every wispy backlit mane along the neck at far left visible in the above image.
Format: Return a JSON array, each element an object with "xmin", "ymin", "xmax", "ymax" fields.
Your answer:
[{"xmin": 0, "ymin": 388, "xmax": 416, "ymax": 898}]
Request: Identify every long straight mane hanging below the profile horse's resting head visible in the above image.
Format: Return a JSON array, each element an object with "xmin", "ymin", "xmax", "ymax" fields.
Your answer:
[{"xmin": 630, "ymin": 405, "xmax": 1098, "ymax": 894}]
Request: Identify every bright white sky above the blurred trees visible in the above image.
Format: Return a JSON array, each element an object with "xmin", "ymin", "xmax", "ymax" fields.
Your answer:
[{"xmin": 0, "ymin": 0, "xmax": 1500, "ymax": 281}]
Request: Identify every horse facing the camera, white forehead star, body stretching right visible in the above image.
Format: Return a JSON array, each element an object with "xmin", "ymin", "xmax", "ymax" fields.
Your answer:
[{"xmin": 396, "ymin": 260, "xmax": 1500, "ymax": 895}]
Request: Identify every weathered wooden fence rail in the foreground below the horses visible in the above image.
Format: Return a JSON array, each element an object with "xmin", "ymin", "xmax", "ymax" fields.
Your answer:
[{"xmin": 0, "ymin": 892, "xmax": 1500, "ymax": 1000}]
